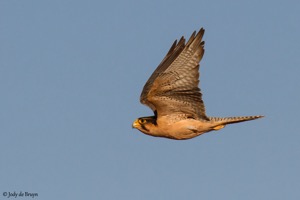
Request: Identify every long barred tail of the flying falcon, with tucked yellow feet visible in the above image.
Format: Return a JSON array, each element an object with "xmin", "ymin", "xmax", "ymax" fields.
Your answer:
[{"xmin": 208, "ymin": 115, "xmax": 264, "ymax": 130}]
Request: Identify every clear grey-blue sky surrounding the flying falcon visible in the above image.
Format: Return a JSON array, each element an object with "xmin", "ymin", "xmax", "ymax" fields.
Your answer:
[{"xmin": 0, "ymin": 0, "xmax": 300, "ymax": 200}]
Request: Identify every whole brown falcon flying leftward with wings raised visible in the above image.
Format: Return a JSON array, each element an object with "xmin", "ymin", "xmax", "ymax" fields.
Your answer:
[{"xmin": 132, "ymin": 28, "xmax": 263, "ymax": 140}]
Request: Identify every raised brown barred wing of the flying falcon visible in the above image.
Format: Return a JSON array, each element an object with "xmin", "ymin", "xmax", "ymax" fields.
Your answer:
[{"xmin": 140, "ymin": 28, "xmax": 209, "ymax": 120}]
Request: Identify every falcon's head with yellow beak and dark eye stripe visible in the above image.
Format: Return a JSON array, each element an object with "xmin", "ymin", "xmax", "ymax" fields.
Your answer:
[{"xmin": 132, "ymin": 116, "xmax": 157, "ymax": 135}]
